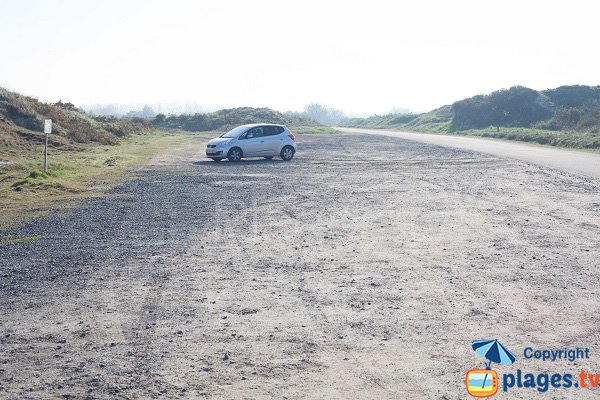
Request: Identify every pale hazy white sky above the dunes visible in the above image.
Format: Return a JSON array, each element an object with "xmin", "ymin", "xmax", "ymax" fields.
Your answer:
[{"xmin": 0, "ymin": 0, "xmax": 600, "ymax": 115}]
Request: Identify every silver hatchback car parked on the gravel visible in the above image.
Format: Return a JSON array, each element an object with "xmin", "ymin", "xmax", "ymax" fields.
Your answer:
[{"xmin": 206, "ymin": 124, "xmax": 298, "ymax": 161}]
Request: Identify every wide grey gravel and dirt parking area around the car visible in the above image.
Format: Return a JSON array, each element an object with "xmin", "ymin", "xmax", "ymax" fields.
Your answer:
[{"xmin": 0, "ymin": 134, "xmax": 600, "ymax": 399}]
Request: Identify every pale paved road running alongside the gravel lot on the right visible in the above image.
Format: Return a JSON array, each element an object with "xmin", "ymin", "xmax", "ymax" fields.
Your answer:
[{"xmin": 336, "ymin": 128, "xmax": 600, "ymax": 178}]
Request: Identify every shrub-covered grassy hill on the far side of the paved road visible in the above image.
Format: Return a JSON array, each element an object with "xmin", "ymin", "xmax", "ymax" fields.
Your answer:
[{"xmin": 342, "ymin": 86, "xmax": 600, "ymax": 149}]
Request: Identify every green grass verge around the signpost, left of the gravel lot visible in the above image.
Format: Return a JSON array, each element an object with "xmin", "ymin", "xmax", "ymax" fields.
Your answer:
[{"xmin": 0, "ymin": 131, "xmax": 212, "ymax": 230}]
